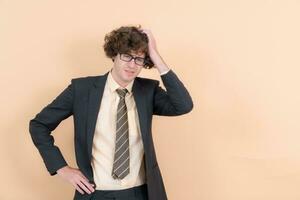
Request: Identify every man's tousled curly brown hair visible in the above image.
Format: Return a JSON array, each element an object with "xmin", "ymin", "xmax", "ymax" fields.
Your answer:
[{"xmin": 103, "ymin": 26, "xmax": 154, "ymax": 69}]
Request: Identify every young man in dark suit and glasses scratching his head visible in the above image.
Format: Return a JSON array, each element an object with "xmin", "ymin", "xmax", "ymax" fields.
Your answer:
[{"xmin": 29, "ymin": 27, "xmax": 193, "ymax": 200}]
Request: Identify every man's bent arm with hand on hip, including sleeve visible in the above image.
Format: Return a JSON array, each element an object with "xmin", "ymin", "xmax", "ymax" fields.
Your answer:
[{"xmin": 29, "ymin": 81, "xmax": 94, "ymax": 194}]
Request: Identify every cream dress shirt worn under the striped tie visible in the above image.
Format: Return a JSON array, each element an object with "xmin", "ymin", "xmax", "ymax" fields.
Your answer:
[{"xmin": 91, "ymin": 72, "xmax": 146, "ymax": 190}]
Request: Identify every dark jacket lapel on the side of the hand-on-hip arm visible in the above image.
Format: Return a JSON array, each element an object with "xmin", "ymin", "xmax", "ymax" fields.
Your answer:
[{"xmin": 87, "ymin": 73, "xmax": 108, "ymax": 160}]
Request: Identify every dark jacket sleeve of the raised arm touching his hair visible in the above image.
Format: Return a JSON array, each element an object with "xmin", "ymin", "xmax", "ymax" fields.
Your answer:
[{"xmin": 153, "ymin": 70, "xmax": 193, "ymax": 116}]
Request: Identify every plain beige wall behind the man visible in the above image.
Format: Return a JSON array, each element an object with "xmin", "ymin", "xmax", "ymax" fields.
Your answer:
[{"xmin": 0, "ymin": 0, "xmax": 300, "ymax": 200}]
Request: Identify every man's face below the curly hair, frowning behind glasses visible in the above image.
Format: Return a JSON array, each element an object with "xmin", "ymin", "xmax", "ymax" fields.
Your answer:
[{"xmin": 112, "ymin": 52, "xmax": 145, "ymax": 87}]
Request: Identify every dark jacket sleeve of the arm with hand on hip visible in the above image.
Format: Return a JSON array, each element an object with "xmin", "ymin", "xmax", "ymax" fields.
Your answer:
[{"xmin": 29, "ymin": 81, "xmax": 74, "ymax": 175}]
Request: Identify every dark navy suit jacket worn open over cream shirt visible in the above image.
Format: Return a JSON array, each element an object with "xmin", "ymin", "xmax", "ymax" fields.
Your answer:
[{"xmin": 29, "ymin": 70, "xmax": 193, "ymax": 200}]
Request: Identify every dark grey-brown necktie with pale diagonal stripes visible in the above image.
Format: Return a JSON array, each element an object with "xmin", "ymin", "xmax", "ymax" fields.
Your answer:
[{"xmin": 112, "ymin": 89, "xmax": 129, "ymax": 179}]
